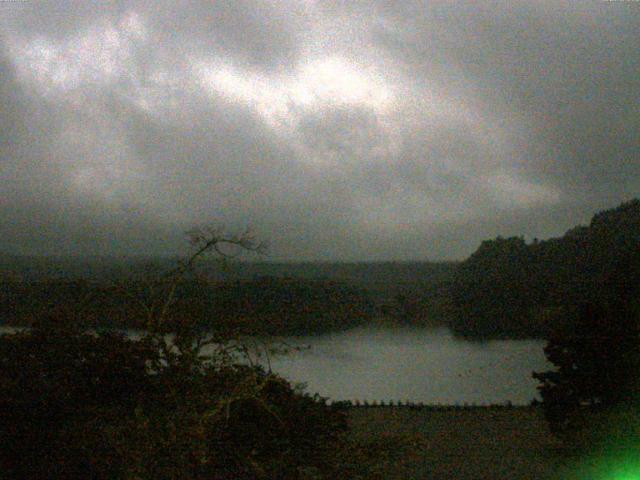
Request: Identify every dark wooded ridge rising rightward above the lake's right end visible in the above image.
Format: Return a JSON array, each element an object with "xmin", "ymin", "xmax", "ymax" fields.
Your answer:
[{"xmin": 451, "ymin": 199, "xmax": 640, "ymax": 337}]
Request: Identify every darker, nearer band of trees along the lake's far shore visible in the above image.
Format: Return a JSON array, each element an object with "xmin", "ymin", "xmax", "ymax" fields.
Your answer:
[{"xmin": 0, "ymin": 277, "xmax": 375, "ymax": 335}]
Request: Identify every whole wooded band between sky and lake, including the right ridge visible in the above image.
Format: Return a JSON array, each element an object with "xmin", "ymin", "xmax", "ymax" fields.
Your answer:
[{"xmin": 0, "ymin": 199, "xmax": 640, "ymax": 339}]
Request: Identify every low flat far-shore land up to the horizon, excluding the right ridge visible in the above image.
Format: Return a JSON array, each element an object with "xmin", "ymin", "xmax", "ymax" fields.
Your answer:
[{"xmin": 0, "ymin": 255, "xmax": 455, "ymax": 334}]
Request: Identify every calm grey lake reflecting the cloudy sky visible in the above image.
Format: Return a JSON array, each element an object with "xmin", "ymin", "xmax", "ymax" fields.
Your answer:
[{"xmin": 0, "ymin": 326, "xmax": 551, "ymax": 404}]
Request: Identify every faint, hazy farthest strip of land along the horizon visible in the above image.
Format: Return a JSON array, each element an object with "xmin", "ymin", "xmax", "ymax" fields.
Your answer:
[{"xmin": 0, "ymin": 253, "xmax": 456, "ymax": 303}]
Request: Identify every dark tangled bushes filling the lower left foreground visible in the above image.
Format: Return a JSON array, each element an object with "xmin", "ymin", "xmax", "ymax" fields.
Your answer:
[{"xmin": 0, "ymin": 322, "xmax": 346, "ymax": 479}]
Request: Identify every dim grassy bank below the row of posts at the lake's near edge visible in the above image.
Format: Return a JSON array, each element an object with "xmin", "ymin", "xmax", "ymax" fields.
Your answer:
[{"xmin": 349, "ymin": 407, "xmax": 563, "ymax": 480}]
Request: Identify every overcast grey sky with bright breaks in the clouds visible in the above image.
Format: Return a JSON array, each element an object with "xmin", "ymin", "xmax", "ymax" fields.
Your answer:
[{"xmin": 0, "ymin": 0, "xmax": 640, "ymax": 260}]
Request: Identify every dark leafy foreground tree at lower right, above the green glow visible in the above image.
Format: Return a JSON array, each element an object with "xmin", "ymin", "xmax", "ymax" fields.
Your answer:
[{"xmin": 533, "ymin": 293, "xmax": 640, "ymax": 462}]
